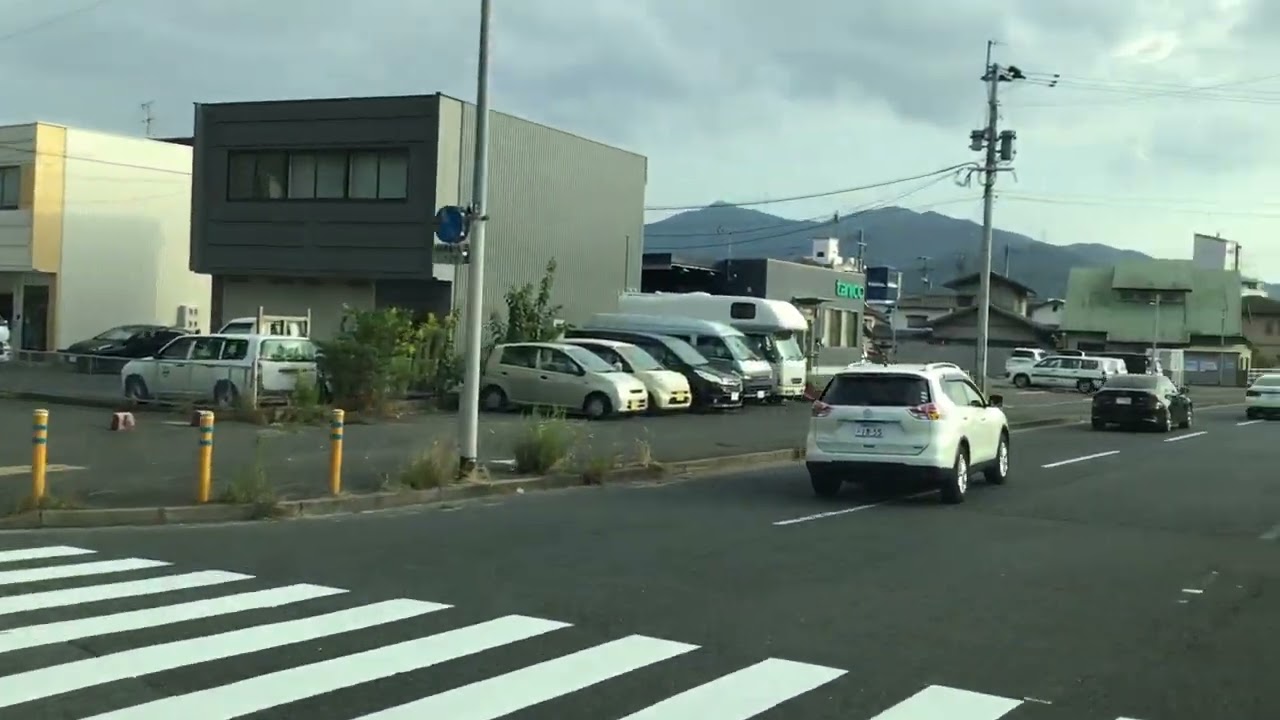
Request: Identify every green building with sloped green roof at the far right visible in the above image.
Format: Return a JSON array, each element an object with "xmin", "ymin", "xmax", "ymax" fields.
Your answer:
[{"xmin": 1060, "ymin": 260, "xmax": 1251, "ymax": 384}]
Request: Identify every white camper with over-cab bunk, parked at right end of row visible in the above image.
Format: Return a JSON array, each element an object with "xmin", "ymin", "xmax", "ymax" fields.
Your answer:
[{"xmin": 618, "ymin": 292, "xmax": 809, "ymax": 398}]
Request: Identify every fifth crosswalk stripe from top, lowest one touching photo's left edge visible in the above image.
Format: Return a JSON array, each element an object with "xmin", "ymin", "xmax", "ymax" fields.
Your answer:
[{"xmin": 0, "ymin": 600, "xmax": 448, "ymax": 707}]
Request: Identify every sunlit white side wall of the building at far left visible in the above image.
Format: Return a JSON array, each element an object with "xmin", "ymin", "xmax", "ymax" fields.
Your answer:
[{"xmin": 56, "ymin": 128, "xmax": 210, "ymax": 347}]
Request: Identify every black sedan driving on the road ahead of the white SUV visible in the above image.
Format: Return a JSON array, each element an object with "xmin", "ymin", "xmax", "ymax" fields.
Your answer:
[{"xmin": 1092, "ymin": 375, "xmax": 1196, "ymax": 433}]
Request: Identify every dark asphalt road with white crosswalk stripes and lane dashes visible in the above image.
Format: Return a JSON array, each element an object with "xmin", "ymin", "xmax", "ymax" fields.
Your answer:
[{"xmin": 0, "ymin": 399, "xmax": 1280, "ymax": 720}]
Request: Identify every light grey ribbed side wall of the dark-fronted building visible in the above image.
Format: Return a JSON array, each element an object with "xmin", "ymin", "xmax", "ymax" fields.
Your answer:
[{"xmin": 438, "ymin": 97, "xmax": 648, "ymax": 340}]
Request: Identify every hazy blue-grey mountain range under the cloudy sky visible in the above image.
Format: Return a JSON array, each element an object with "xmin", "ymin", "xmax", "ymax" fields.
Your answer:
[{"xmin": 644, "ymin": 202, "xmax": 1280, "ymax": 299}]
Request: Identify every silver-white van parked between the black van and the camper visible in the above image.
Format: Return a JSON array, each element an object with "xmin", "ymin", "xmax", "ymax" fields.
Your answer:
[{"xmin": 579, "ymin": 313, "xmax": 777, "ymax": 400}]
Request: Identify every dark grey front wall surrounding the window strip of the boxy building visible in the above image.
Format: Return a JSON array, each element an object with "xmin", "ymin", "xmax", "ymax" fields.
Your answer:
[{"xmin": 191, "ymin": 95, "xmax": 439, "ymax": 279}]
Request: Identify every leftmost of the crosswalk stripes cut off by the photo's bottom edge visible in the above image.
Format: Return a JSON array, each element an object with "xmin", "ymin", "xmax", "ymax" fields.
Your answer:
[{"xmin": 86, "ymin": 615, "xmax": 568, "ymax": 720}]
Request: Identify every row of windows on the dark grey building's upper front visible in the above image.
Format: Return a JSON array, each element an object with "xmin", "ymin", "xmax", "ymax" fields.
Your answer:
[{"xmin": 227, "ymin": 149, "xmax": 408, "ymax": 200}]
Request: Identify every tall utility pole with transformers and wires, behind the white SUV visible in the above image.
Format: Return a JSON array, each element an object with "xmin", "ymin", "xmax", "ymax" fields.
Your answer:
[{"xmin": 969, "ymin": 41, "xmax": 1027, "ymax": 393}]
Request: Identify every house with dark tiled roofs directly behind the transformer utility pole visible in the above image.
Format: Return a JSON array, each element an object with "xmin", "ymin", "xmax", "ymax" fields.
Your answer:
[{"xmin": 931, "ymin": 273, "xmax": 1053, "ymax": 347}]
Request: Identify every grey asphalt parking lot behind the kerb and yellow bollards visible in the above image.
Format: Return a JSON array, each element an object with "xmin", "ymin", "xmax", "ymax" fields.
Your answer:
[{"xmin": 0, "ymin": 388, "xmax": 1177, "ymax": 509}]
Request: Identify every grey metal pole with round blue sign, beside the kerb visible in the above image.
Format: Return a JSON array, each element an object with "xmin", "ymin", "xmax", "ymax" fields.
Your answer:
[{"xmin": 458, "ymin": 0, "xmax": 493, "ymax": 474}]
